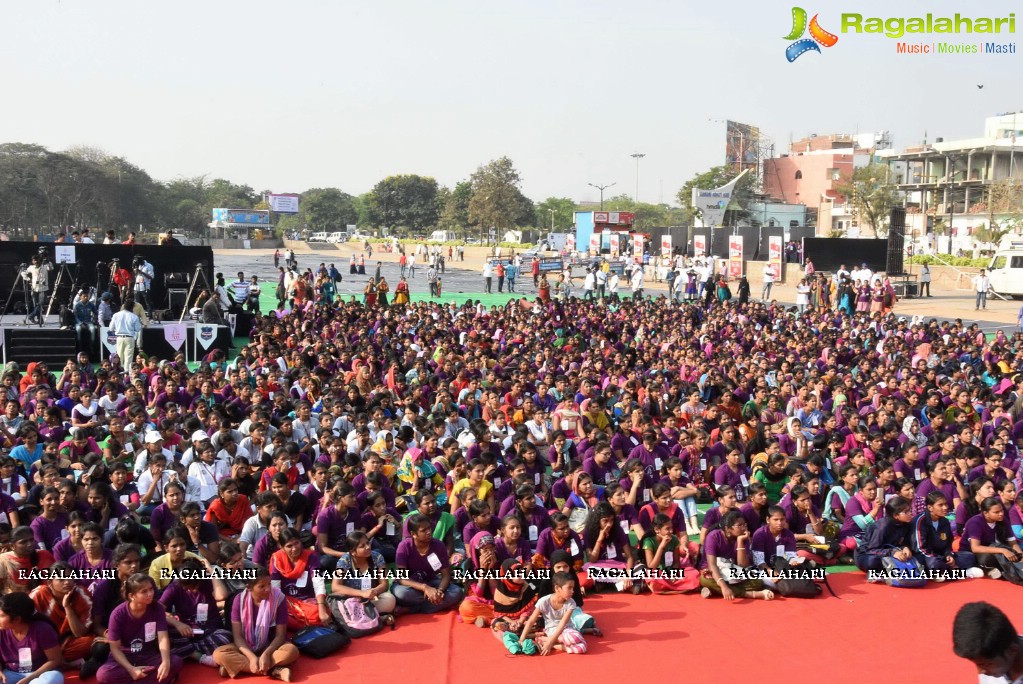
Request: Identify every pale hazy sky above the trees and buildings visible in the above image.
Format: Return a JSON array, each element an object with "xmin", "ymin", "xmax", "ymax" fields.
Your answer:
[{"xmin": 0, "ymin": 0, "xmax": 1023, "ymax": 202}]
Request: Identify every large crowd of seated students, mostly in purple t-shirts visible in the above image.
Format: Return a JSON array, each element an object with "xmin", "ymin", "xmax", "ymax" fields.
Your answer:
[{"xmin": 0, "ymin": 290, "xmax": 1023, "ymax": 684}]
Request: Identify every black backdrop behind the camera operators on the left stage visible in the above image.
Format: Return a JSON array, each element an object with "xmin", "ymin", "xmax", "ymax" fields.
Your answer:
[{"xmin": 0, "ymin": 242, "xmax": 216, "ymax": 311}]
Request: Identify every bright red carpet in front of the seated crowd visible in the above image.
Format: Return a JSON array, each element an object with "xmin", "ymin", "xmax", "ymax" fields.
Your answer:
[{"xmin": 70, "ymin": 573, "xmax": 1023, "ymax": 684}]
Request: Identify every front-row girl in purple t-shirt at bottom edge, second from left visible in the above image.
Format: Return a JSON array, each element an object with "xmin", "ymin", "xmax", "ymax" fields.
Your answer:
[{"xmin": 96, "ymin": 573, "xmax": 182, "ymax": 684}]
